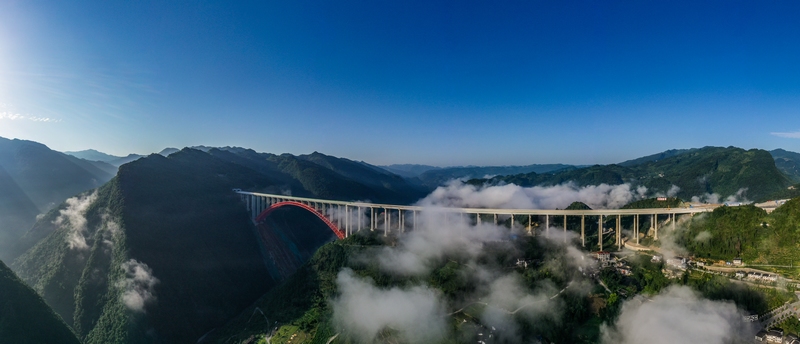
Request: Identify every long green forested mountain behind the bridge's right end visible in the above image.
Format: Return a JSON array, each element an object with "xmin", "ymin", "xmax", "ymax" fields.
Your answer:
[{"xmin": 478, "ymin": 147, "xmax": 792, "ymax": 201}]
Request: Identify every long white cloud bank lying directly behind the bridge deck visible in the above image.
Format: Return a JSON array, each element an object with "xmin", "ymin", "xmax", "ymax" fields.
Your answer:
[{"xmin": 418, "ymin": 180, "xmax": 648, "ymax": 209}]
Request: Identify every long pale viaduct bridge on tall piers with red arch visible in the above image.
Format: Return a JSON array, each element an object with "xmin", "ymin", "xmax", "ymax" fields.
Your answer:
[{"xmin": 234, "ymin": 189, "xmax": 716, "ymax": 251}]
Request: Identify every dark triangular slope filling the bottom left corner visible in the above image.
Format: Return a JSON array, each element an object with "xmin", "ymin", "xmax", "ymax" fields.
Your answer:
[{"xmin": 0, "ymin": 261, "xmax": 80, "ymax": 344}]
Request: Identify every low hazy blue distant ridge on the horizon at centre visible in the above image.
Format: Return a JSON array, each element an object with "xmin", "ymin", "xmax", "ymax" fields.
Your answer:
[{"xmin": 419, "ymin": 164, "xmax": 574, "ymax": 188}]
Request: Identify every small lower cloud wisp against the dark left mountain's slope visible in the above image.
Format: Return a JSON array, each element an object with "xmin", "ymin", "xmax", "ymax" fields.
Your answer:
[{"xmin": 117, "ymin": 259, "xmax": 159, "ymax": 313}]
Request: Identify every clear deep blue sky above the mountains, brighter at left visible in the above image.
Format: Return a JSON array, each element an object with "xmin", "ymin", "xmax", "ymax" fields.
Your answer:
[{"xmin": 0, "ymin": 0, "xmax": 800, "ymax": 166}]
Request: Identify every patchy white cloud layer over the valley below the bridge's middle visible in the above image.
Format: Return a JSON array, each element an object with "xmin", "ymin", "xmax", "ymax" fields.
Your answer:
[{"xmin": 332, "ymin": 210, "xmax": 585, "ymax": 343}]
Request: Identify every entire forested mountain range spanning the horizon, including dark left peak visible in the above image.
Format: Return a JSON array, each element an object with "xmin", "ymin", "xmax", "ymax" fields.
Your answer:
[{"xmin": 0, "ymin": 139, "xmax": 800, "ymax": 343}]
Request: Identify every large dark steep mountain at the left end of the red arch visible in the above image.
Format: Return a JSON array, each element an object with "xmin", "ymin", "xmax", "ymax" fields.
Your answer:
[{"xmin": 13, "ymin": 149, "xmax": 275, "ymax": 343}]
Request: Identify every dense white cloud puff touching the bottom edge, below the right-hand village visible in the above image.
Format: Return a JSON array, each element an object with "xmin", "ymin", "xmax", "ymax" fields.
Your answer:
[{"xmin": 602, "ymin": 286, "xmax": 754, "ymax": 344}]
